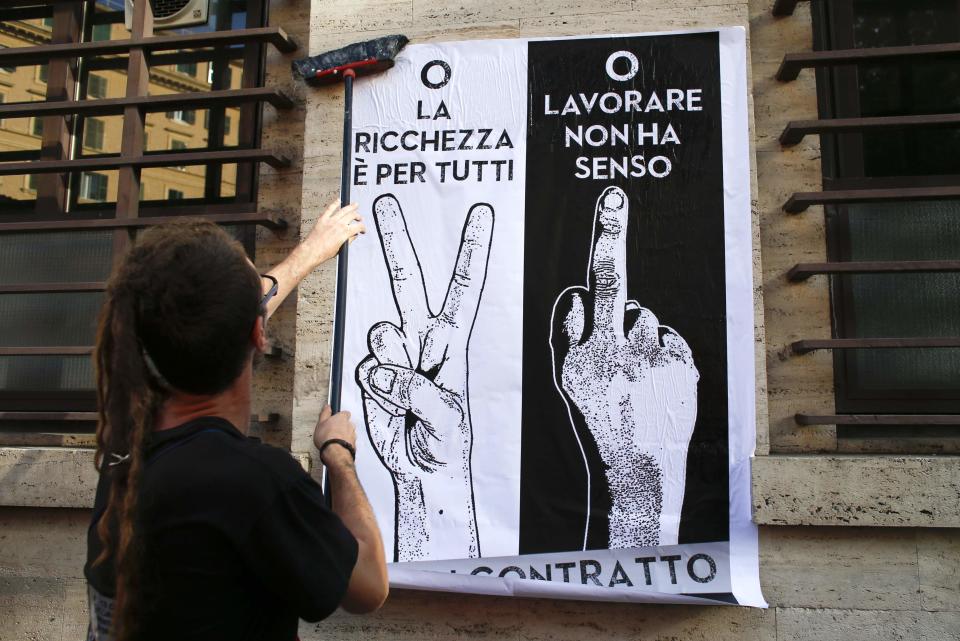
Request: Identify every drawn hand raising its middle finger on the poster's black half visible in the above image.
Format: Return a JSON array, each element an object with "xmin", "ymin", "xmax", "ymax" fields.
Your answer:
[{"xmin": 550, "ymin": 187, "xmax": 700, "ymax": 548}]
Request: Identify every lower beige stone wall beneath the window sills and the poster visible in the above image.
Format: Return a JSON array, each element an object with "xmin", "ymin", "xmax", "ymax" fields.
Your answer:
[{"xmin": 0, "ymin": 508, "xmax": 960, "ymax": 641}]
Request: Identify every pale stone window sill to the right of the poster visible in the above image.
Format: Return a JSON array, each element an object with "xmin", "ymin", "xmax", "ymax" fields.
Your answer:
[{"xmin": 753, "ymin": 454, "xmax": 960, "ymax": 527}]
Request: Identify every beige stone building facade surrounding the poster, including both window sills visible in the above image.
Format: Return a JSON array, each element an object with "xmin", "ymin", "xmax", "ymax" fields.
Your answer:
[{"xmin": 0, "ymin": 0, "xmax": 960, "ymax": 641}]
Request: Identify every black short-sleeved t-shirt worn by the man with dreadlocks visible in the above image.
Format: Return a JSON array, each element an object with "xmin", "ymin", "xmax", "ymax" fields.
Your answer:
[{"xmin": 84, "ymin": 417, "xmax": 357, "ymax": 641}]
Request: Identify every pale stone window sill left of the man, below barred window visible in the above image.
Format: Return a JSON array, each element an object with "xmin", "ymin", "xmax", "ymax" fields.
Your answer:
[{"xmin": 0, "ymin": 447, "xmax": 97, "ymax": 508}]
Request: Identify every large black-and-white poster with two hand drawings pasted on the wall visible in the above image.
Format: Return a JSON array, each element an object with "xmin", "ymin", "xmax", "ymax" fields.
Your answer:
[{"xmin": 342, "ymin": 28, "xmax": 763, "ymax": 605}]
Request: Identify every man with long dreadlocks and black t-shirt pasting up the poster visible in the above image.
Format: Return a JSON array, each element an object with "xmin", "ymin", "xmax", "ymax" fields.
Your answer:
[{"xmin": 84, "ymin": 203, "xmax": 388, "ymax": 641}]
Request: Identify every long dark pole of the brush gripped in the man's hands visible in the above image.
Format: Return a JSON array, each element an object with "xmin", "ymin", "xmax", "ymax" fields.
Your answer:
[{"xmin": 323, "ymin": 69, "xmax": 354, "ymax": 507}]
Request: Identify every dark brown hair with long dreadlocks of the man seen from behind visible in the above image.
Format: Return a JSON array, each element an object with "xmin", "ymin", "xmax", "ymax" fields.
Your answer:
[{"xmin": 94, "ymin": 221, "xmax": 262, "ymax": 641}]
